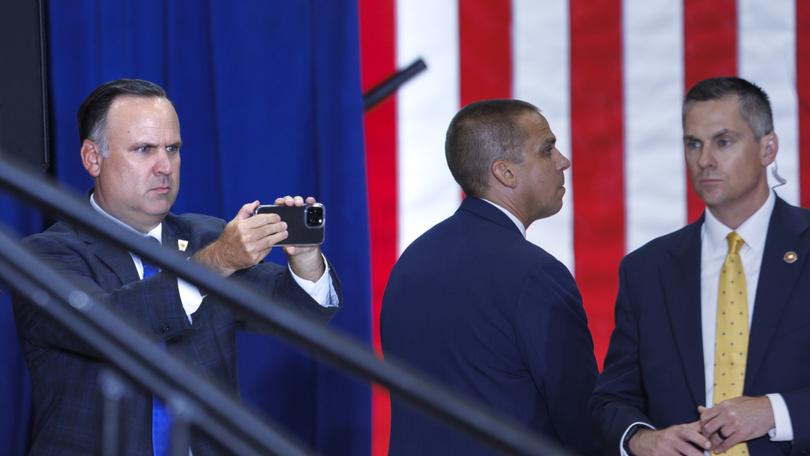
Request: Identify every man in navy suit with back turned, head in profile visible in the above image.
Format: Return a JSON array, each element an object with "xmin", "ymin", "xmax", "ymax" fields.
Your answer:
[{"xmin": 380, "ymin": 100, "xmax": 597, "ymax": 455}]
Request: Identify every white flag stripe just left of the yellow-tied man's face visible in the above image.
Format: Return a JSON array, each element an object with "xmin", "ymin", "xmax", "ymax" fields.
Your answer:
[{"xmin": 617, "ymin": 0, "xmax": 687, "ymax": 251}]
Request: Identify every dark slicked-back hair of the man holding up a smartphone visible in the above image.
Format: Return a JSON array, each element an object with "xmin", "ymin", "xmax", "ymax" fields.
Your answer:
[{"xmin": 76, "ymin": 79, "xmax": 168, "ymax": 156}]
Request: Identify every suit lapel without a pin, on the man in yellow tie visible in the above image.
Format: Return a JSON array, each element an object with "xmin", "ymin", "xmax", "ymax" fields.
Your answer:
[{"xmin": 661, "ymin": 223, "xmax": 706, "ymax": 404}]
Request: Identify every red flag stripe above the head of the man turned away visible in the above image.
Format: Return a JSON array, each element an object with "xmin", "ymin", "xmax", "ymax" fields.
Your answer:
[{"xmin": 458, "ymin": 0, "xmax": 512, "ymax": 106}]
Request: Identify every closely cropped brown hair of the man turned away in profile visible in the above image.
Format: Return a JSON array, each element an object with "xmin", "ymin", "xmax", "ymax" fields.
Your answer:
[{"xmin": 444, "ymin": 100, "xmax": 540, "ymax": 197}]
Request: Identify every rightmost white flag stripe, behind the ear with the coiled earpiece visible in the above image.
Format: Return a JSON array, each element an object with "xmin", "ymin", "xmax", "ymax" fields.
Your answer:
[{"xmin": 737, "ymin": 0, "xmax": 806, "ymax": 204}]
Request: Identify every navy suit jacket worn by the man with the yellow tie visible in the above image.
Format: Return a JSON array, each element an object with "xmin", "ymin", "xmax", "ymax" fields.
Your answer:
[{"xmin": 593, "ymin": 198, "xmax": 810, "ymax": 456}]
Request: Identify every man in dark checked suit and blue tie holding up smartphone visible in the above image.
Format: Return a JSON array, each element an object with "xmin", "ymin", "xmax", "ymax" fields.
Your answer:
[{"xmin": 14, "ymin": 79, "xmax": 340, "ymax": 456}]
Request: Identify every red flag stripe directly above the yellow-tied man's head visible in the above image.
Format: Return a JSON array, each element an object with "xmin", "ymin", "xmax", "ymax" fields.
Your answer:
[{"xmin": 683, "ymin": 0, "xmax": 737, "ymax": 222}]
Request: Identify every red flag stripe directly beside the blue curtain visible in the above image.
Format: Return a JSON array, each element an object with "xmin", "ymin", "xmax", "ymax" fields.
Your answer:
[{"xmin": 359, "ymin": 0, "xmax": 397, "ymax": 456}]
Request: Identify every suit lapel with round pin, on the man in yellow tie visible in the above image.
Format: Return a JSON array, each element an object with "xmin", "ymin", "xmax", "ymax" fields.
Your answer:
[{"xmin": 745, "ymin": 199, "xmax": 810, "ymax": 391}]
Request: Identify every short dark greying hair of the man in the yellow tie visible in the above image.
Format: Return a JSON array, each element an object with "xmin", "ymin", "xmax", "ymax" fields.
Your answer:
[{"xmin": 683, "ymin": 77, "xmax": 773, "ymax": 139}]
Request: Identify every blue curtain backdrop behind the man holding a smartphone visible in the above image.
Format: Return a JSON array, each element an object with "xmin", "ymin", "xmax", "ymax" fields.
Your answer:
[{"xmin": 0, "ymin": 0, "xmax": 371, "ymax": 455}]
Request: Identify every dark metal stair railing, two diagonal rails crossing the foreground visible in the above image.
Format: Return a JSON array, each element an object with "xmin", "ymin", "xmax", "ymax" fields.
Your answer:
[{"xmin": 0, "ymin": 156, "xmax": 570, "ymax": 455}]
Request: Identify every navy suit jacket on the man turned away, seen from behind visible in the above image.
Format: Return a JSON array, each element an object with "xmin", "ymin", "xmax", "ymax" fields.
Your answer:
[{"xmin": 380, "ymin": 198, "xmax": 597, "ymax": 455}]
